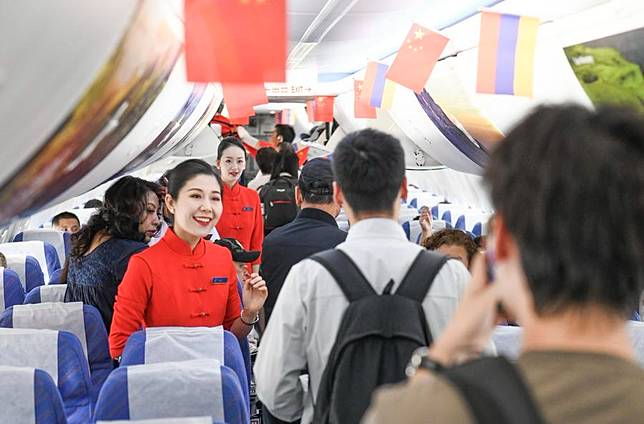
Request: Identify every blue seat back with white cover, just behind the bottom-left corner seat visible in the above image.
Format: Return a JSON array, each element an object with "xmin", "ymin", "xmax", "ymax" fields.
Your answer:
[{"xmin": 0, "ymin": 328, "xmax": 92, "ymax": 424}]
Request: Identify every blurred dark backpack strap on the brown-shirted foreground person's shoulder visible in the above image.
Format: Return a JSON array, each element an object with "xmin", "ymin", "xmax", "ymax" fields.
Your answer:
[{"xmin": 442, "ymin": 357, "xmax": 545, "ymax": 424}]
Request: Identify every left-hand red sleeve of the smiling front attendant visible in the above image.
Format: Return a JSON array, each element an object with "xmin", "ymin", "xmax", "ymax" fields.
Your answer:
[{"xmin": 110, "ymin": 256, "xmax": 152, "ymax": 358}]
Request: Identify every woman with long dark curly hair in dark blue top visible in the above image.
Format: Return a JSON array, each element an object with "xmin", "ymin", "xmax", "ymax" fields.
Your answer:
[{"xmin": 61, "ymin": 176, "xmax": 159, "ymax": 330}]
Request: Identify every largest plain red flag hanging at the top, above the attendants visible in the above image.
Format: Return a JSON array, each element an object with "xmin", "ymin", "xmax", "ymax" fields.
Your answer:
[{"xmin": 184, "ymin": 0, "xmax": 287, "ymax": 83}]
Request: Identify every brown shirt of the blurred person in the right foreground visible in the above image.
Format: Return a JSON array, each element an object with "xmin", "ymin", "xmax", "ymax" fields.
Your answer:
[{"xmin": 363, "ymin": 351, "xmax": 644, "ymax": 424}]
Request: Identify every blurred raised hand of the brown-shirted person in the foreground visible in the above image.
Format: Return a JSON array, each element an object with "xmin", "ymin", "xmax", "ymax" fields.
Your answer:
[{"xmin": 429, "ymin": 254, "xmax": 500, "ymax": 366}]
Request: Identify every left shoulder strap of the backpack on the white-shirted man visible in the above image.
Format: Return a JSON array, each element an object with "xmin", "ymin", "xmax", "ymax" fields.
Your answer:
[{"xmin": 309, "ymin": 249, "xmax": 378, "ymax": 302}]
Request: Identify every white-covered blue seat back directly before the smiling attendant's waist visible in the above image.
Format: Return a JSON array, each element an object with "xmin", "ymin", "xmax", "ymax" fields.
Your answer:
[{"xmin": 121, "ymin": 326, "xmax": 250, "ymax": 402}]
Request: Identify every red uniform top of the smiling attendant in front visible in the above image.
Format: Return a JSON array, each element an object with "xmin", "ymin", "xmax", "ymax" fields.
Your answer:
[{"xmin": 110, "ymin": 228, "xmax": 241, "ymax": 358}]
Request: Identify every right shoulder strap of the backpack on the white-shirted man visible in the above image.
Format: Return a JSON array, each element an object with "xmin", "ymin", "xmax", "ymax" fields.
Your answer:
[{"xmin": 396, "ymin": 250, "xmax": 448, "ymax": 303}]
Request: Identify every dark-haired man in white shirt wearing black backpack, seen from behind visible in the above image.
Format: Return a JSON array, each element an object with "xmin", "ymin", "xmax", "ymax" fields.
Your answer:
[{"xmin": 255, "ymin": 129, "xmax": 469, "ymax": 423}]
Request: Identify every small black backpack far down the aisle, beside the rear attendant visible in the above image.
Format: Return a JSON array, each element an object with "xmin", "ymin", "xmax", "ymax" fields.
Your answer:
[{"xmin": 259, "ymin": 176, "xmax": 298, "ymax": 234}]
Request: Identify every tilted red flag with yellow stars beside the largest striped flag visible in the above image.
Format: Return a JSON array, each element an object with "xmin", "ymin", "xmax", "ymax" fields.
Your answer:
[{"xmin": 387, "ymin": 24, "xmax": 449, "ymax": 93}]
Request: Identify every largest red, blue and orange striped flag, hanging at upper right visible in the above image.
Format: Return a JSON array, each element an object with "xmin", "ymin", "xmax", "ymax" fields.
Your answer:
[{"xmin": 476, "ymin": 11, "xmax": 539, "ymax": 97}]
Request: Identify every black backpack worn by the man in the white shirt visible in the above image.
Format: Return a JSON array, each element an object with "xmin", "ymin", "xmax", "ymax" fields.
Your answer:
[{"xmin": 311, "ymin": 249, "xmax": 447, "ymax": 424}]
